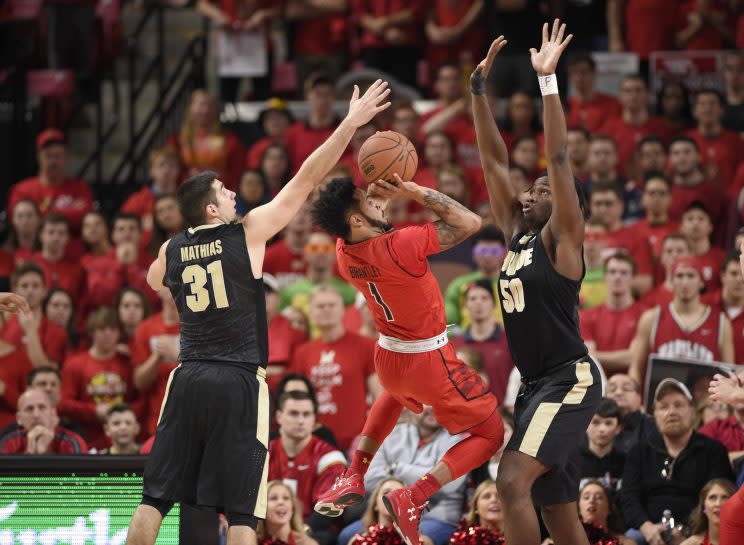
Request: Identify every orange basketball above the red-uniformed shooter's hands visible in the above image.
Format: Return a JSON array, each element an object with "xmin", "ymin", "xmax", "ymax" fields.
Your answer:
[{"xmin": 357, "ymin": 131, "xmax": 418, "ymax": 183}]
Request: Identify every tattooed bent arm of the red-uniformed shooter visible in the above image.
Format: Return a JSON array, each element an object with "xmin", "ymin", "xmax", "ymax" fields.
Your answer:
[{"xmin": 368, "ymin": 174, "xmax": 481, "ymax": 250}]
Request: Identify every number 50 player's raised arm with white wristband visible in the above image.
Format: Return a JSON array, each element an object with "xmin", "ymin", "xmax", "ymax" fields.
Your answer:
[{"xmin": 530, "ymin": 19, "xmax": 584, "ymax": 249}]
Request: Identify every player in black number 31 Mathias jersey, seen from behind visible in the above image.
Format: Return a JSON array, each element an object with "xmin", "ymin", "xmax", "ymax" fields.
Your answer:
[{"xmin": 127, "ymin": 80, "xmax": 390, "ymax": 545}]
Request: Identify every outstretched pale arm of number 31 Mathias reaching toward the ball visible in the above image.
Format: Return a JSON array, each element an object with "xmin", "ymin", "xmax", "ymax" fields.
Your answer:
[{"xmin": 243, "ymin": 79, "xmax": 390, "ymax": 245}]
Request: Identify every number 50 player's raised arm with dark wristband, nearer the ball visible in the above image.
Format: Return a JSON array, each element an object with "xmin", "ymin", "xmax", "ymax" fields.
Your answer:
[{"xmin": 470, "ymin": 36, "xmax": 518, "ymax": 242}]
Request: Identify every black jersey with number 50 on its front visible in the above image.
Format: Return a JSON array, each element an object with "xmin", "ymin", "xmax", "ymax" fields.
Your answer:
[{"xmin": 499, "ymin": 233, "xmax": 587, "ymax": 379}]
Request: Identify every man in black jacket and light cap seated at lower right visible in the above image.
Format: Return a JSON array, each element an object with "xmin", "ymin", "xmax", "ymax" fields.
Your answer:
[{"xmin": 620, "ymin": 378, "xmax": 733, "ymax": 545}]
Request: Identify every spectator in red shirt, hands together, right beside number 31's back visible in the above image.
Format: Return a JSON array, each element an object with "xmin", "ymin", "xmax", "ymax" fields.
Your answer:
[{"xmin": 131, "ymin": 288, "xmax": 181, "ymax": 435}]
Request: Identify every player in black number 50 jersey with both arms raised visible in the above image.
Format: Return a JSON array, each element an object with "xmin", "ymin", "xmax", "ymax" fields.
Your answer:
[{"xmin": 471, "ymin": 20, "xmax": 602, "ymax": 545}]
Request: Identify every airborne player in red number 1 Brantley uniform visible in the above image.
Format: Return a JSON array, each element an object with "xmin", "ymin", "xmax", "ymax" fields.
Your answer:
[{"xmin": 313, "ymin": 175, "xmax": 504, "ymax": 545}]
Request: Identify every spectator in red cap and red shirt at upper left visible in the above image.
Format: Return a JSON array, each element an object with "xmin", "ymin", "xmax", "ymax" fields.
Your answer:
[{"xmin": 7, "ymin": 129, "xmax": 93, "ymax": 240}]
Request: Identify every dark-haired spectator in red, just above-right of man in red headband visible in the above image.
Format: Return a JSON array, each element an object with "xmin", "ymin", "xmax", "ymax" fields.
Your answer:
[{"xmin": 679, "ymin": 202, "xmax": 725, "ymax": 291}]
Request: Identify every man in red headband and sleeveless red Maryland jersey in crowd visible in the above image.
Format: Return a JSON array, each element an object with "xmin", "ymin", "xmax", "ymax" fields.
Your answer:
[{"xmin": 628, "ymin": 256, "xmax": 734, "ymax": 384}]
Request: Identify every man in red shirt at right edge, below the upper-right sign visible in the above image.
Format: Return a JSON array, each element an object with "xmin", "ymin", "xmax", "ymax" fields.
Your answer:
[{"xmin": 687, "ymin": 89, "xmax": 744, "ymax": 196}]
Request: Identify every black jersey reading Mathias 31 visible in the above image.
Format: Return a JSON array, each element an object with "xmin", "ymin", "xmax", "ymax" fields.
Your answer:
[{"xmin": 163, "ymin": 223, "xmax": 268, "ymax": 367}]
